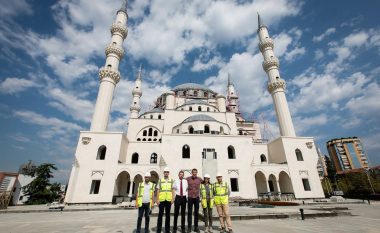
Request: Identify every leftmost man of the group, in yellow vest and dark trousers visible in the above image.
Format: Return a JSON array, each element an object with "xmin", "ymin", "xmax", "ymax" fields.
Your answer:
[{"xmin": 136, "ymin": 172, "xmax": 155, "ymax": 233}]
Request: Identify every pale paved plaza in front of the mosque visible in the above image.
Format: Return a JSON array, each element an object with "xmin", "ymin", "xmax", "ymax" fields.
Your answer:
[{"xmin": 0, "ymin": 203, "xmax": 380, "ymax": 233}]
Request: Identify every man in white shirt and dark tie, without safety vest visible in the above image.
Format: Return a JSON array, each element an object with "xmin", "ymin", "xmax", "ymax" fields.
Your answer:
[{"xmin": 173, "ymin": 170, "xmax": 188, "ymax": 233}]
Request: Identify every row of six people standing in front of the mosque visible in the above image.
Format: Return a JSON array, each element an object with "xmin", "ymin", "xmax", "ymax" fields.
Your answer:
[{"xmin": 136, "ymin": 168, "xmax": 232, "ymax": 233}]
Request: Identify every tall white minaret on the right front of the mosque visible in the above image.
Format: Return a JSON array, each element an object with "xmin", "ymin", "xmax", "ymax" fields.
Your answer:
[{"xmin": 257, "ymin": 14, "xmax": 296, "ymax": 137}]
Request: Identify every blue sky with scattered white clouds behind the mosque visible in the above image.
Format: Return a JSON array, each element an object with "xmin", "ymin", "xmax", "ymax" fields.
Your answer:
[{"xmin": 0, "ymin": 0, "xmax": 380, "ymax": 182}]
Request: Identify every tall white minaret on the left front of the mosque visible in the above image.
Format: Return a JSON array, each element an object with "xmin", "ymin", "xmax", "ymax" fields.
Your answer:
[{"xmin": 90, "ymin": 0, "xmax": 128, "ymax": 132}]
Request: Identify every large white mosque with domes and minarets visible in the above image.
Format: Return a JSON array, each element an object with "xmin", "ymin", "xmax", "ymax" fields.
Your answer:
[{"xmin": 65, "ymin": 5, "xmax": 324, "ymax": 204}]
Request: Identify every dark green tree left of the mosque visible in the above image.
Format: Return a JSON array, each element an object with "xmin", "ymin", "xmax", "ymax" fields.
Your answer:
[{"xmin": 23, "ymin": 163, "xmax": 59, "ymax": 204}]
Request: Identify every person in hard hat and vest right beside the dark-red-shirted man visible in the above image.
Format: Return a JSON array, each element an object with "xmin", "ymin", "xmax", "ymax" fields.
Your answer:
[{"xmin": 200, "ymin": 174, "xmax": 214, "ymax": 232}]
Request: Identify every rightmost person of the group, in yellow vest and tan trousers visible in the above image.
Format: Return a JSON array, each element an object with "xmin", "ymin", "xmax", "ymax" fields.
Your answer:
[{"xmin": 214, "ymin": 173, "xmax": 233, "ymax": 233}]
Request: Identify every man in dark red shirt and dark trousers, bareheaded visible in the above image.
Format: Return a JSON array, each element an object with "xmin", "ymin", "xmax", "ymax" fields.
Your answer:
[{"xmin": 186, "ymin": 168, "xmax": 203, "ymax": 232}]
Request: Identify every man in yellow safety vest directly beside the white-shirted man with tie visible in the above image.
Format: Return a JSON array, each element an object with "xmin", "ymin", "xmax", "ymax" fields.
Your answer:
[{"xmin": 156, "ymin": 167, "xmax": 174, "ymax": 233}]
